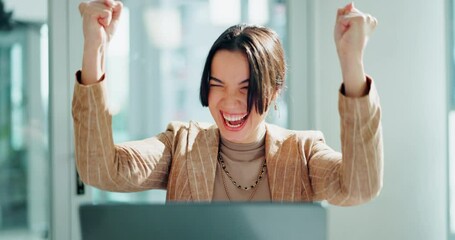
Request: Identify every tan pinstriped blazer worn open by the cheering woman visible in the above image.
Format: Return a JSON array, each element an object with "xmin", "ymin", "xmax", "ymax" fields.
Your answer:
[{"xmin": 72, "ymin": 74, "xmax": 383, "ymax": 205}]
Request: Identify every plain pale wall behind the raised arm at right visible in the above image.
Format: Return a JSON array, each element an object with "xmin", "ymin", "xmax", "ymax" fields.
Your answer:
[{"xmin": 313, "ymin": 0, "xmax": 449, "ymax": 240}]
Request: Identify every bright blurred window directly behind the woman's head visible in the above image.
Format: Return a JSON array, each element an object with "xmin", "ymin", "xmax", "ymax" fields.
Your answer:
[{"xmin": 93, "ymin": 0, "xmax": 287, "ymax": 202}]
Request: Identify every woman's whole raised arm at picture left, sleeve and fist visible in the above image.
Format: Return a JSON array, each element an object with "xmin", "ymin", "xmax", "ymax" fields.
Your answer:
[{"xmin": 72, "ymin": 1, "xmax": 176, "ymax": 192}]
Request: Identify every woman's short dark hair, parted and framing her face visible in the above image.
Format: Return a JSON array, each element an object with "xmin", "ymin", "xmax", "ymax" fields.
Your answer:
[{"xmin": 199, "ymin": 24, "xmax": 286, "ymax": 114}]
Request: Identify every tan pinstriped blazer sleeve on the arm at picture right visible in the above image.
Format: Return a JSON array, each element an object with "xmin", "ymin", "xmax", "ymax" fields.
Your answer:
[{"xmin": 308, "ymin": 78, "xmax": 383, "ymax": 206}]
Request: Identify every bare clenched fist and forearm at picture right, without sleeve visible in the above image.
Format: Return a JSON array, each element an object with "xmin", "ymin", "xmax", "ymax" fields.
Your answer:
[{"xmin": 334, "ymin": 3, "xmax": 377, "ymax": 97}]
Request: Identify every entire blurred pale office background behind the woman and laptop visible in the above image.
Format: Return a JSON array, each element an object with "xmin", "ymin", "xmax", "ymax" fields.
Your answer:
[{"xmin": 0, "ymin": 0, "xmax": 455, "ymax": 240}]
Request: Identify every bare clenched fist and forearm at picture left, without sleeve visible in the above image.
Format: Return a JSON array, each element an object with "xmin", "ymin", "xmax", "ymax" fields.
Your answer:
[{"xmin": 79, "ymin": 0, "xmax": 123, "ymax": 84}]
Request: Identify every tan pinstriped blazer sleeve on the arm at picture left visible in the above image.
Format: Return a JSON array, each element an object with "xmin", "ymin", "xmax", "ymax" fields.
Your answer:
[{"xmin": 72, "ymin": 72, "xmax": 180, "ymax": 192}]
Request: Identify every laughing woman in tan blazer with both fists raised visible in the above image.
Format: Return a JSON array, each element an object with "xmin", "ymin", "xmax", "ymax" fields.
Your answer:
[{"xmin": 73, "ymin": 0, "xmax": 383, "ymax": 205}]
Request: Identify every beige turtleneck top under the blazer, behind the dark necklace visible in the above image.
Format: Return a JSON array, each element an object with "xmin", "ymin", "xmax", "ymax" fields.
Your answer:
[{"xmin": 213, "ymin": 133, "xmax": 271, "ymax": 201}]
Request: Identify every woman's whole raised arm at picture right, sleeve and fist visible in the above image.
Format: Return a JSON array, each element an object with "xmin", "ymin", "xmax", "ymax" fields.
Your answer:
[{"xmin": 308, "ymin": 3, "xmax": 383, "ymax": 206}]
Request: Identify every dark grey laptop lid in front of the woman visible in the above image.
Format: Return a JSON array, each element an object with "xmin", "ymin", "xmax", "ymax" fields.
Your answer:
[{"xmin": 79, "ymin": 203, "xmax": 327, "ymax": 240}]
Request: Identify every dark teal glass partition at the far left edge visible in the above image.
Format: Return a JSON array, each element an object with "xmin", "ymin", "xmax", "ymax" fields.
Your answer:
[{"xmin": 0, "ymin": 1, "xmax": 50, "ymax": 240}]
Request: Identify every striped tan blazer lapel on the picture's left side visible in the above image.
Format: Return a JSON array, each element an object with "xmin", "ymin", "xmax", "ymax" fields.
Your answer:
[{"xmin": 186, "ymin": 122, "xmax": 219, "ymax": 202}]
